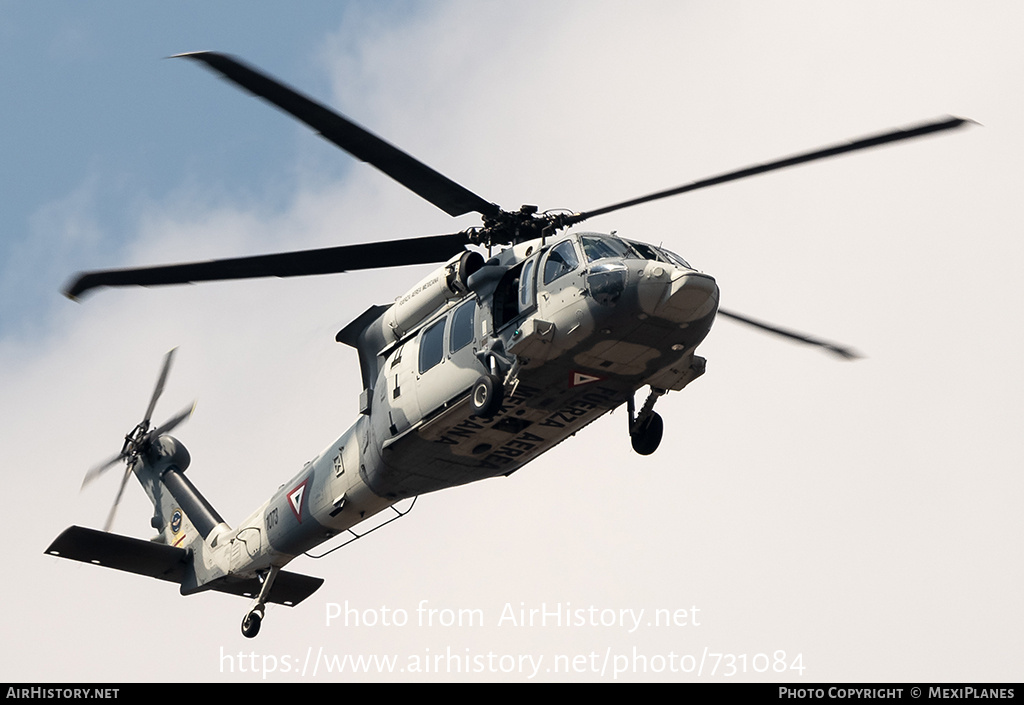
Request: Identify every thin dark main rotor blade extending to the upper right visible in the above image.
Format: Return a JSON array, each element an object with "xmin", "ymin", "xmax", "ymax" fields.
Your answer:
[{"xmin": 569, "ymin": 117, "xmax": 973, "ymax": 223}]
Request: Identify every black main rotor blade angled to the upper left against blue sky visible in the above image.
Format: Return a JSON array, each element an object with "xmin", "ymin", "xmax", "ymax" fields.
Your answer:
[{"xmin": 176, "ymin": 51, "xmax": 500, "ymax": 215}]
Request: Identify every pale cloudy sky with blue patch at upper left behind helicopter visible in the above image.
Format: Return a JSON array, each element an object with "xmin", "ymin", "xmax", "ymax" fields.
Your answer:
[{"xmin": 0, "ymin": 0, "xmax": 1024, "ymax": 683}]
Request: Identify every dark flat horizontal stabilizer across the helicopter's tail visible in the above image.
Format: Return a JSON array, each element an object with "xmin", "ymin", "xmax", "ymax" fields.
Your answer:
[{"xmin": 46, "ymin": 527, "xmax": 324, "ymax": 607}]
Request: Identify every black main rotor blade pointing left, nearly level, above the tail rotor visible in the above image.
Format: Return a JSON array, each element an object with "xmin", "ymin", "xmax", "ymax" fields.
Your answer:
[{"xmin": 65, "ymin": 233, "xmax": 470, "ymax": 300}]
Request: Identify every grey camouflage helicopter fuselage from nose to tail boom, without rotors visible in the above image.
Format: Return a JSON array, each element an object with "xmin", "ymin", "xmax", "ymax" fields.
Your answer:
[{"xmin": 238, "ymin": 233, "xmax": 718, "ymax": 566}]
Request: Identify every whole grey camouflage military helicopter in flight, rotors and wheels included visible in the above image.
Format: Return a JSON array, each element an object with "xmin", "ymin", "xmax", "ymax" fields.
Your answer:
[{"xmin": 46, "ymin": 51, "xmax": 971, "ymax": 637}]
